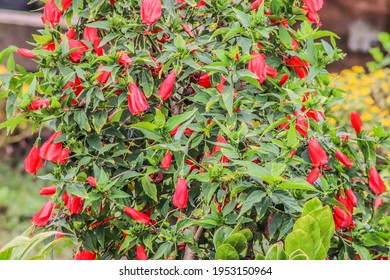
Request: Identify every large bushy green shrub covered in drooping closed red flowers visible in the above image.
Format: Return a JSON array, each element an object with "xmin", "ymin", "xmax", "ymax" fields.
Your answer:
[{"xmin": 0, "ymin": 0, "xmax": 389, "ymax": 259}]
